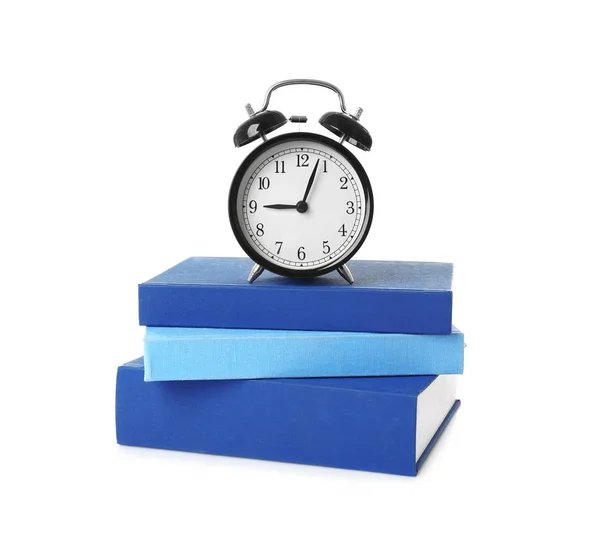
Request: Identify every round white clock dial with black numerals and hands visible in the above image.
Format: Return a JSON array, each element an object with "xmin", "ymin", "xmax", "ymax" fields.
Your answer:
[{"xmin": 236, "ymin": 135, "xmax": 371, "ymax": 271}]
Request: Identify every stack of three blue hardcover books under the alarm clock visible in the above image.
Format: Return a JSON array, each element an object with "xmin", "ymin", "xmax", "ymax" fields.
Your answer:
[{"xmin": 116, "ymin": 258, "xmax": 464, "ymax": 475}]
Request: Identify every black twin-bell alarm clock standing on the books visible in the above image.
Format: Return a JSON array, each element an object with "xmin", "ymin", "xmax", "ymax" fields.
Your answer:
[{"xmin": 229, "ymin": 79, "xmax": 373, "ymax": 283}]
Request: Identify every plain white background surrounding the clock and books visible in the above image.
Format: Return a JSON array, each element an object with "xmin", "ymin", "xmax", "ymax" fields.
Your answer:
[{"xmin": 0, "ymin": 0, "xmax": 600, "ymax": 532}]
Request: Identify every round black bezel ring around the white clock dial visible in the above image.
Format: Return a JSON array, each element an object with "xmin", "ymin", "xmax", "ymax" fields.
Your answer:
[{"xmin": 229, "ymin": 132, "xmax": 374, "ymax": 278}]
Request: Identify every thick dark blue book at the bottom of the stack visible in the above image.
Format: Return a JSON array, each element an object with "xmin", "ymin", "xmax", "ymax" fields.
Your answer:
[{"xmin": 116, "ymin": 359, "xmax": 460, "ymax": 476}]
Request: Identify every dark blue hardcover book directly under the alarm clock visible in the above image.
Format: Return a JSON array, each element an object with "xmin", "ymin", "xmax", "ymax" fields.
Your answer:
[{"xmin": 139, "ymin": 257, "xmax": 452, "ymax": 335}]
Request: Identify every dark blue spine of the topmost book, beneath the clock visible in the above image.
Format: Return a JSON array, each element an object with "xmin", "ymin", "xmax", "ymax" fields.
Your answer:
[{"xmin": 139, "ymin": 283, "xmax": 452, "ymax": 335}]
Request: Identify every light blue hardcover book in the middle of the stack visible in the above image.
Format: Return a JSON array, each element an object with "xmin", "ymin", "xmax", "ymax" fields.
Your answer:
[{"xmin": 144, "ymin": 327, "xmax": 464, "ymax": 381}]
